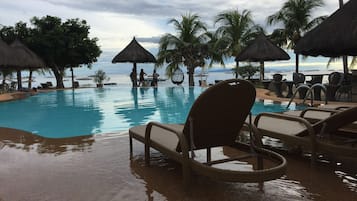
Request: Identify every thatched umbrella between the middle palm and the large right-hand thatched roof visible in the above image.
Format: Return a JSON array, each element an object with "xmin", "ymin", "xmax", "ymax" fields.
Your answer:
[{"xmin": 235, "ymin": 34, "xmax": 290, "ymax": 80}]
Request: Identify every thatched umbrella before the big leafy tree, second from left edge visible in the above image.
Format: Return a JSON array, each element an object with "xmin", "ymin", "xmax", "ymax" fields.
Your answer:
[{"xmin": 10, "ymin": 40, "xmax": 45, "ymax": 89}]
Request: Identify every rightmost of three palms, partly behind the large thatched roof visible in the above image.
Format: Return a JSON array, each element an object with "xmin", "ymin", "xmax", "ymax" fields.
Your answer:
[{"xmin": 267, "ymin": 0, "xmax": 326, "ymax": 72}]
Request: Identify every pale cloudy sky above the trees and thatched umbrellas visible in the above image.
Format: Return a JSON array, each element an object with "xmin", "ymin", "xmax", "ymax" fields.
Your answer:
[{"xmin": 0, "ymin": 0, "xmax": 340, "ymax": 51}]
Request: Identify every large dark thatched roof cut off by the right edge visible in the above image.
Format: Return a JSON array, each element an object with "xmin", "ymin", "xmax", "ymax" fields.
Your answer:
[{"xmin": 294, "ymin": 0, "xmax": 357, "ymax": 73}]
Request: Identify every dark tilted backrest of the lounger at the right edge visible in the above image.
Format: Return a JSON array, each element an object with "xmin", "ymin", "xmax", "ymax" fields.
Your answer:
[{"xmin": 320, "ymin": 107, "xmax": 357, "ymax": 135}]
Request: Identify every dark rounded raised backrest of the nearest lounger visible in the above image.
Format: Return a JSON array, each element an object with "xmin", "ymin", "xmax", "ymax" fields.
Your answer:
[{"xmin": 183, "ymin": 79, "xmax": 256, "ymax": 149}]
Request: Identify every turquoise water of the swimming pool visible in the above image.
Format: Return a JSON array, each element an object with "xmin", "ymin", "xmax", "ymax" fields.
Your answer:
[{"xmin": 0, "ymin": 86, "xmax": 302, "ymax": 138}]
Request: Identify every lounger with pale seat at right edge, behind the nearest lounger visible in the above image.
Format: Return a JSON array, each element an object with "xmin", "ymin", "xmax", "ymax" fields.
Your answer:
[{"xmin": 254, "ymin": 107, "xmax": 357, "ymax": 162}]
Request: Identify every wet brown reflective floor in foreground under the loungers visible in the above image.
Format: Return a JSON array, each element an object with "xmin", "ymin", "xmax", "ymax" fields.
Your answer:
[{"xmin": 0, "ymin": 132, "xmax": 357, "ymax": 201}]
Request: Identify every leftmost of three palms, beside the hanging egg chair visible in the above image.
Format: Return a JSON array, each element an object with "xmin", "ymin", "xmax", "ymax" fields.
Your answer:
[{"xmin": 156, "ymin": 14, "xmax": 207, "ymax": 86}]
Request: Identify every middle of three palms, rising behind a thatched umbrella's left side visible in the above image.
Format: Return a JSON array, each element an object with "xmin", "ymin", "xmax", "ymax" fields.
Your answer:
[{"xmin": 215, "ymin": 10, "xmax": 261, "ymax": 75}]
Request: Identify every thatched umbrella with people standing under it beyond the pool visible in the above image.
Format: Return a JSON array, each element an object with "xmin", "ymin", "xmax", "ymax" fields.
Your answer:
[{"xmin": 112, "ymin": 37, "xmax": 156, "ymax": 87}]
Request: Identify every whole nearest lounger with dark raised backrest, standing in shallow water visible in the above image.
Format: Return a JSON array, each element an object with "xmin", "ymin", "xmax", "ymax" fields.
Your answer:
[{"xmin": 129, "ymin": 79, "xmax": 286, "ymax": 186}]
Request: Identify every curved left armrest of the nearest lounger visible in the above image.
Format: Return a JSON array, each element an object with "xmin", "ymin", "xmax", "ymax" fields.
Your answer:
[{"xmin": 145, "ymin": 122, "xmax": 189, "ymax": 159}]
